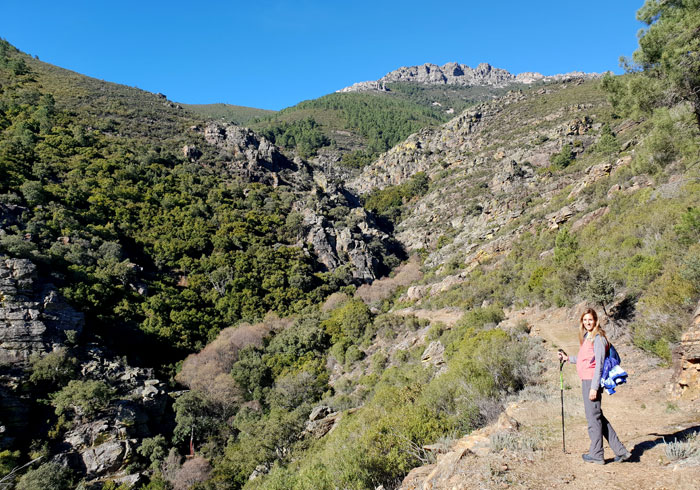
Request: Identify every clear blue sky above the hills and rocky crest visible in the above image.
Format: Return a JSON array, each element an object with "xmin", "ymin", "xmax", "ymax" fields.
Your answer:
[{"xmin": 0, "ymin": 0, "xmax": 643, "ymax": 109}]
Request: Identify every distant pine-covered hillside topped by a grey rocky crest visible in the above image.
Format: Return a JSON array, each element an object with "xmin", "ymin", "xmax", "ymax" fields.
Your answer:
[{"xmin": 245, "ymin": 63, "xmax": 599, "ymax": 174}]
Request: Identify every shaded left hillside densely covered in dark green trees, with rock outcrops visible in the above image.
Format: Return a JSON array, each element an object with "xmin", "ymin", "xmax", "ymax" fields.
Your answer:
[{"xmin": 0, "ymin": 41, "xmax": 402, "ymax": 487}]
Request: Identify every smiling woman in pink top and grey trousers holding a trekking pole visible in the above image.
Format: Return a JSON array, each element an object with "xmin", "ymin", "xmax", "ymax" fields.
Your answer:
[{"xmin": 559, "ymin": 308, "xmax": 632, "ymax": 464}]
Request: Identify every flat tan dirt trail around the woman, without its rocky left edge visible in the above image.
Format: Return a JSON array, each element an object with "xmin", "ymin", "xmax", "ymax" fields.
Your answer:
[{"xmin": 498, "ymin": 308, "xmax": 700, "ymax": 489}]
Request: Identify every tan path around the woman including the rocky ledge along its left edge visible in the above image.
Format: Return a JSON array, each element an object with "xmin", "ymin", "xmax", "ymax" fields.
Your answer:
[{"xmin": 401, "ymin": 308, "xmax": 700, "ymax": 489}]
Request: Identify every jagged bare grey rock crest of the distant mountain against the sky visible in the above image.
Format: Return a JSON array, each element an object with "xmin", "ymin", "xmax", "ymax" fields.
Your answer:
[{"xmin": 338, "ymin": 62, "xmax": 601, "ymax": 92}]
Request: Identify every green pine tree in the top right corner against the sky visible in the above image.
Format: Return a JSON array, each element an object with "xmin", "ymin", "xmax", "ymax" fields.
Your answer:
[{"xmin": 633, "ymin": 0, "xmax": 700, "ymax": 126}]
